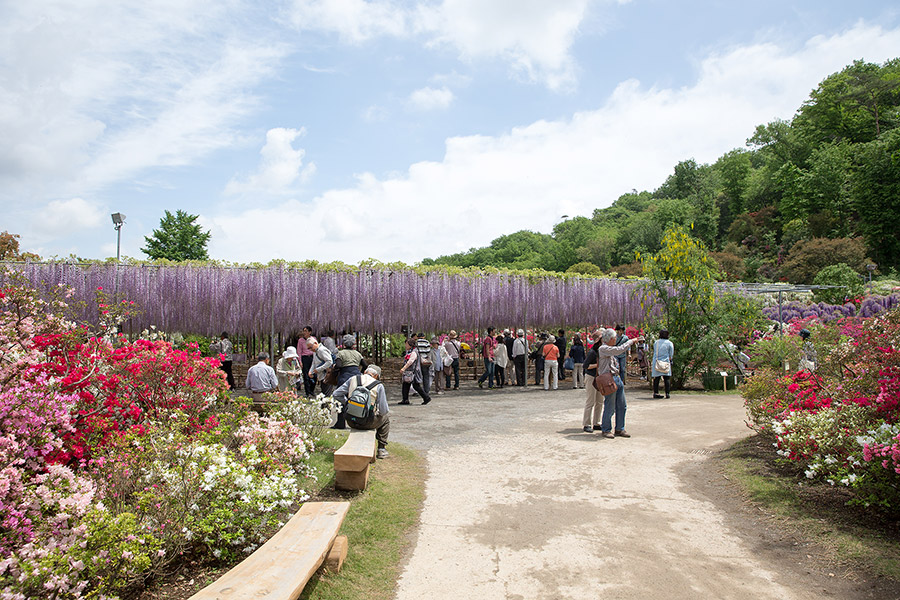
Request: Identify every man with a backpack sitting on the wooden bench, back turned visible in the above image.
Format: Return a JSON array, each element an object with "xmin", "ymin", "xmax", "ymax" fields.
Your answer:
[{"xmin": 332, "ymin": 365, "xmax": 391, "ymax": 458}]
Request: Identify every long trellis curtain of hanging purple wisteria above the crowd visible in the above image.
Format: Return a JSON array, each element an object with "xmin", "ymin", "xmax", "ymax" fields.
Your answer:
[{"xmin": 1, "ymin": 262, "xmax": 645, "ymax": 334}]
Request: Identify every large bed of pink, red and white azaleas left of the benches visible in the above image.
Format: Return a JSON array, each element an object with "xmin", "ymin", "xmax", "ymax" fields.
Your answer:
[{"xmin": 0, "ymin": 284, "xmax": 330, "ymax": 599}]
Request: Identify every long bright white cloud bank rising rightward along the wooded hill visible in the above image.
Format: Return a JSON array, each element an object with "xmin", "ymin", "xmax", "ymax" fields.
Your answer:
[{"xmin": 211, "ymin": 24, "xmax": 900, "ymax": 262}]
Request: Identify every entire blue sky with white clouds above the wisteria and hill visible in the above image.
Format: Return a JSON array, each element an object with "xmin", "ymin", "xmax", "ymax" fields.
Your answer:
[{"xmin": 0, "ymin": 0, "xmax": 900, "ymax": 263}]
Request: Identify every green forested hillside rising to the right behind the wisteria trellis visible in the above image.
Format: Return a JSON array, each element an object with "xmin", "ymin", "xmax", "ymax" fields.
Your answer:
[{"xmin": 423, "ymin": 59, "xmax": 900, "ymax": 283}]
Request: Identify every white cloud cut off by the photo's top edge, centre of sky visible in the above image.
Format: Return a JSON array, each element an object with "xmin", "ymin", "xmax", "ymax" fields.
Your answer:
[{"xmin": 291, "ymin": 0, "xmax": 600, "ymax": 89}]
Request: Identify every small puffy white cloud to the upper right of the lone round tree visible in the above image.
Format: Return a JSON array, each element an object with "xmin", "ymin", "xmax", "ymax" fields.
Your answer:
[{"xmin": 225, "ymin": 127, "xmax": 316, "ymax": 195}]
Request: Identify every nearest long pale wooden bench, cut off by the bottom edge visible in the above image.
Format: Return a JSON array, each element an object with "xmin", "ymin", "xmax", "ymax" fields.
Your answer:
[{"xmin": 190, "ymin": 502, "xmax": 350, "ymax": 600}]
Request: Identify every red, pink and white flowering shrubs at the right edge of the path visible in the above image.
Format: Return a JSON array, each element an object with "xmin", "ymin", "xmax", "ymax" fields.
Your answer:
[{"xmin": 742, "ymin": 309, "xmax": 900, "ymax": 513}]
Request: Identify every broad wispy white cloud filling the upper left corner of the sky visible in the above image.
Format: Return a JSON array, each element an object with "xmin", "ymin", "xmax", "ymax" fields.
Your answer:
[{"xmin": 0, "ymin": 0, "xmax": 285, "ymax": 197}]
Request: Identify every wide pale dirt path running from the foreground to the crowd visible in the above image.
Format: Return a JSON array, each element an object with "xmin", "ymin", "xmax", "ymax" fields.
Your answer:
[{"xmin": 391, "ymin": 382, "xmax": 884, "ymax": 600}]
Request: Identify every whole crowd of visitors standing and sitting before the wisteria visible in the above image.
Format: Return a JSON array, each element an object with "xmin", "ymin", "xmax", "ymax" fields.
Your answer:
[{"xmin": 221, "ymin": 325, "xmax": 675, "ymax": 458}]
